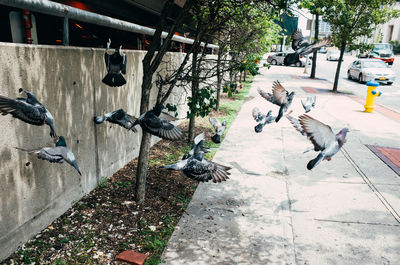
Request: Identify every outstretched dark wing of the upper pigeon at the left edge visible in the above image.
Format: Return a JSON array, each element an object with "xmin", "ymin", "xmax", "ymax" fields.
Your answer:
[{"xmin": 0, "ymin": 96, "xmax": 45, "ymax": 125}]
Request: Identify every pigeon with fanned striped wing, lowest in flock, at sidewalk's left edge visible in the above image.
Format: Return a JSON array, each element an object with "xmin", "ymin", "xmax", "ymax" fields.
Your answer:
[{"xmin": 161, "ymin": 134, "xmax": 231, "ymax": 183}]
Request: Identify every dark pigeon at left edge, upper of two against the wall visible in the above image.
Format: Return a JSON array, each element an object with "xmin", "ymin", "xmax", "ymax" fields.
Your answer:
[{"xmin": 0, "ymin": 89, "xmax": 57, "ymax": 137}]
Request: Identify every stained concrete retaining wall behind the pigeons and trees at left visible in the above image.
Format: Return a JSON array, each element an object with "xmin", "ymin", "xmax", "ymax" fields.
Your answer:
[{"xmin": 0, "ymin": 43, "xmax": 190, "ymax": 261}]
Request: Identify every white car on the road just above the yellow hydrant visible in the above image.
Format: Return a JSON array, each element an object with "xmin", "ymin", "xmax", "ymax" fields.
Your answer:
[{"xmin": 347, "ymin": 59, "xmax": 396, "ymax": 85}]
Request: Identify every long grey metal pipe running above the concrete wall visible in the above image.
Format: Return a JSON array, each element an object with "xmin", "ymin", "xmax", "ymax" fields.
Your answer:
[{"xmin": 0, "ymin": 0, "xmax": 219, "ymax": 49}]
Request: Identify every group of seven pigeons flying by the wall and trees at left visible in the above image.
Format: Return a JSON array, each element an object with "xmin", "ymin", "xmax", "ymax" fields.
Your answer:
[{"xmin": 0, "ymin": 41, "xmax": 230, "ymax": 182}]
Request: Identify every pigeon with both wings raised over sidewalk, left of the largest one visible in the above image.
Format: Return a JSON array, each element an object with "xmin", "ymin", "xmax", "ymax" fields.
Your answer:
[{"xmin": 258, "ymin": 81, "xmax": 295, "ymax": 122}]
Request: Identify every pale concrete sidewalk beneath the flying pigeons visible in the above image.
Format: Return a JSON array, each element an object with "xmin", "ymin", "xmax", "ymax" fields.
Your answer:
[{"xmin": 162, "ymin": 67, "xmax": 400, "ymax": 265}]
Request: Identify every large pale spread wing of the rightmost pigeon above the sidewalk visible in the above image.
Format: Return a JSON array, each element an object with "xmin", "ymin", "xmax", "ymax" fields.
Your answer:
[{"xmin": 299, "ymin": 114, "xmax": 336, "ymax": 150}]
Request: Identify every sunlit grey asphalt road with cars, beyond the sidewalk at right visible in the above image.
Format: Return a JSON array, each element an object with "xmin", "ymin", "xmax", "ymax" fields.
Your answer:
[{"xmin": 308, "ymin": 53, "xmax": 400, "ymax": 112}]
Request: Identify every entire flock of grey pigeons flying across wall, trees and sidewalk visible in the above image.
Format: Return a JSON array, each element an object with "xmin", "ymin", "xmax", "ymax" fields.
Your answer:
[{"xmin": 0, "ymin": 30, "xmax": 348, "ymax": 182}]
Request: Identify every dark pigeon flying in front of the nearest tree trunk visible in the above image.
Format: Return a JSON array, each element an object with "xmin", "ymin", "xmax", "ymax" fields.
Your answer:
[{"xmin": 129, "ymin": 104, "xmax": 183, "ymax": 140}]
